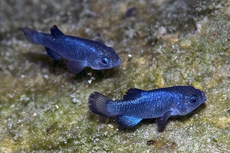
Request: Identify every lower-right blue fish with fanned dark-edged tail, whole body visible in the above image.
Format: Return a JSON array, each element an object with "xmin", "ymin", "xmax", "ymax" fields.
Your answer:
[{"xmin": 89, "ymin": 86, "xmax": 206, "ymax": 128}]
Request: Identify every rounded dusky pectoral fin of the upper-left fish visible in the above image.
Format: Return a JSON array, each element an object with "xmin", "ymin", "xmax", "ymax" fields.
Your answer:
[{"xmin": 67, "ymin": 61, "xmax": 87, "ymax": 73}]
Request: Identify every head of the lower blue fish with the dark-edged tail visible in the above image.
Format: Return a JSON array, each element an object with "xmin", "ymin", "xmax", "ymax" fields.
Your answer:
[{"xmin": 177, "ymin": 86, "xmax": 207, "ymax": 115}]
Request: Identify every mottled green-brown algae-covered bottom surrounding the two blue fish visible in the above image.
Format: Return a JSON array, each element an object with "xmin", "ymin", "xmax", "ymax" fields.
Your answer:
[{"xmin": 0, "ymin": 0, "xmax": 230, "ymax": 152}]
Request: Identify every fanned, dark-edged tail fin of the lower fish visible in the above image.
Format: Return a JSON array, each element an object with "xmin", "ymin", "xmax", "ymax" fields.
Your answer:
[{"xmin": 89, "ymin": 92, "xmax": 113, "ymax": 116}]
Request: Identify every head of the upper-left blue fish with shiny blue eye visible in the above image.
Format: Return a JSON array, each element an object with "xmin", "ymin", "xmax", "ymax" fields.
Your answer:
[{"xmin": 88, "ymin": 46, "xmax": 121, "ymax": 70}]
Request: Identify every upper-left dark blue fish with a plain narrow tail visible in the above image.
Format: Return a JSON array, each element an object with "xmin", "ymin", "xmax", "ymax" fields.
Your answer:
[{"xmin": 19, "ymin": 25, "xmax": 121, "ymax": 73}]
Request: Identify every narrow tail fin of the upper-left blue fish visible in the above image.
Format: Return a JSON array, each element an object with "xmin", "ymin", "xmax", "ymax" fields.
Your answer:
[{"xmin": 18, "ymin": 28, "xmax": 42, "ymax": 44}]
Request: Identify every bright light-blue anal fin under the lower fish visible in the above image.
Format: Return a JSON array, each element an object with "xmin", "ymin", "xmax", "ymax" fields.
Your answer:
[{"xmin": 115, "ymin": 116, "xmax": 142, "ymax": 128}]
